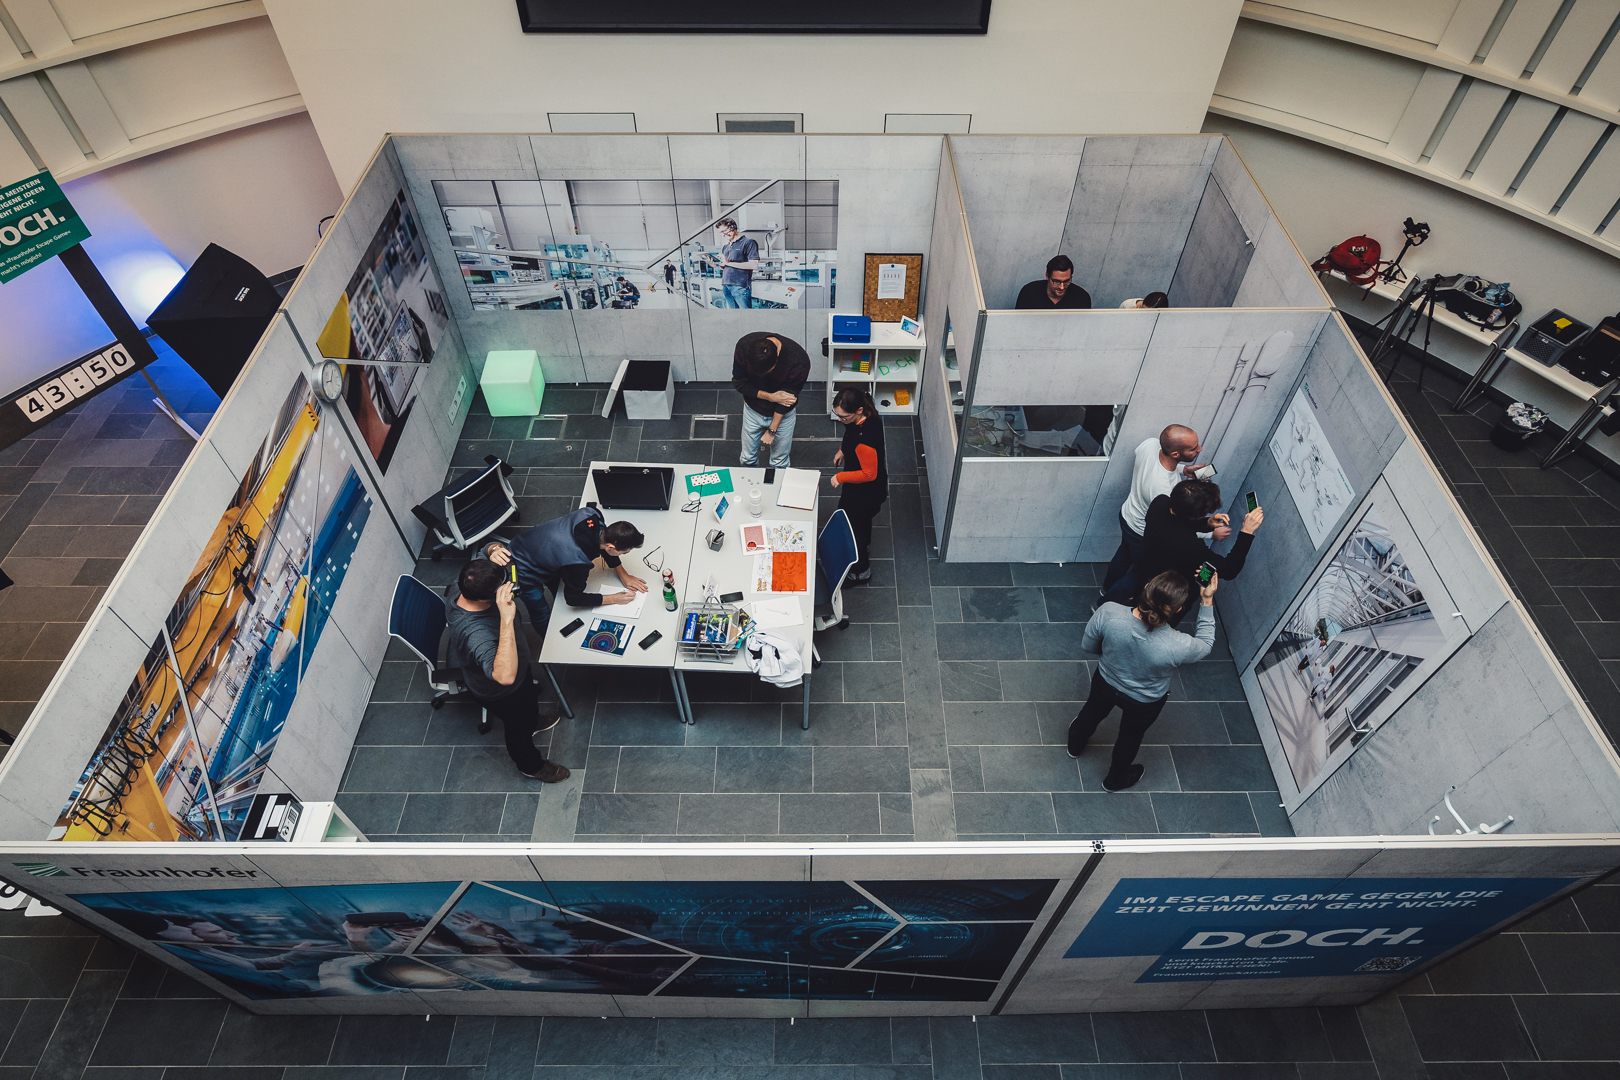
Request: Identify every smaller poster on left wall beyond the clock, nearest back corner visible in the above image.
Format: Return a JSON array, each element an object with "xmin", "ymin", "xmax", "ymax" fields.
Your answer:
[{"xmin": 316, "ymin": 191, "xmax": 450, "ymax": 473}]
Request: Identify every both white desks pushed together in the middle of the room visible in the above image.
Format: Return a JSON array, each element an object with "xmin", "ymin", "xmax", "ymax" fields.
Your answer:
[{"xmin": 538, "ymin": 461, "xmax": 816, "ymax": 727}]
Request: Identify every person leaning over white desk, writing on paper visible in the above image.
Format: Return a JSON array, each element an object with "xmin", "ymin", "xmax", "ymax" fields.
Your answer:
[{"xmin": 484, "ymin": 507, "xmax": 646, "ymax": 633}]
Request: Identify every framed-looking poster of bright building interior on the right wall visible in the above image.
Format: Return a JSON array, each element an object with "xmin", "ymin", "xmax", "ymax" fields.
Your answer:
[{"xmin": 1254, "ymin": 502, "xmax": 1447, "ymax": 792}]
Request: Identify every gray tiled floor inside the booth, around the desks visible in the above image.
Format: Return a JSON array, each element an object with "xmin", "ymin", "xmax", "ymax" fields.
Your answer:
[{"xmin": 339, "ymin": 389, "xmax": 1290, "ymax": 842}]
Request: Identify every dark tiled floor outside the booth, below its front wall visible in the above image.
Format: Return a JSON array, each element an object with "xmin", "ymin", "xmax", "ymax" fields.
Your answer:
[{"xmin": 12, "ymin": 884, "xmax": 1620, "ymax": 1080}]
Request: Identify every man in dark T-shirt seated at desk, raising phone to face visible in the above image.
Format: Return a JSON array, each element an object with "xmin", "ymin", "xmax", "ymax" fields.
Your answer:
[{"xmin": 444, "ymin": 559, "xmax": 569, "ymax": 784}]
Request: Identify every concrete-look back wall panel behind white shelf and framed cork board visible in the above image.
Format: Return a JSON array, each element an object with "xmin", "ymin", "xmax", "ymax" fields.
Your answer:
[{"xmin": 805, "ymin": 134, "xmax": 944, "ymax": 313}]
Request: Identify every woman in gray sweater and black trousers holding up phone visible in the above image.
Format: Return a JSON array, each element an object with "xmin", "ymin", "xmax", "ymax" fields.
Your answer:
[{"xmin": 1069, "ymin": 570, "xmax": 1217, "ymax": 792}]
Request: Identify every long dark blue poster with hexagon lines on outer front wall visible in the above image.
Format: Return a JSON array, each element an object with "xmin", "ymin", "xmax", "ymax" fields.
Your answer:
[{"xmin": 75, "ymin": 879, "xmax": 1056, "ymax": 1001}]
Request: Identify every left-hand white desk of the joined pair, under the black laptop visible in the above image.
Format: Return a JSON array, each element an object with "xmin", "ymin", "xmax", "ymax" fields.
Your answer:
[{"xmin": 538, "ymin": 461, "xmax": 713, "ymax": 721}]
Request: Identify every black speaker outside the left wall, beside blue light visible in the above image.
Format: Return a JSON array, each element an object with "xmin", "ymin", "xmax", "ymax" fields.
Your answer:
[{"xmin": 146, "ymin": 244, "xmax": 280, "ymax": 397}]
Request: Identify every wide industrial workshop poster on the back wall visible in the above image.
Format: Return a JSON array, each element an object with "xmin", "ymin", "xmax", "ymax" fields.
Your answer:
[{"xmin": 433, "ymin": 180, "xmax": 860, "ymax": 311}]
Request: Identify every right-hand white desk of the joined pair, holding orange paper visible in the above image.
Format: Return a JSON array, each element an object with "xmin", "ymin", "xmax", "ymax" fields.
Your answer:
[{"xmin": 676, "ymin": 466, "xmax": 816, "ymax": 727}]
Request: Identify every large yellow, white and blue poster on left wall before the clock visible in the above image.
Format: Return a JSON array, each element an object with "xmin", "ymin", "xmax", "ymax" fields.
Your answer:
[{"xmin": 52, "ymin": 376, "xmax": 371, "ymax": 840}]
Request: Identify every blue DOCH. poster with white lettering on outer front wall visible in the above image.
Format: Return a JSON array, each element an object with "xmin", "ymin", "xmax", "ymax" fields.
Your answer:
[{"xmin": 1063, "ymin": 878, "xmax": 1576, "ymax": 983}]
